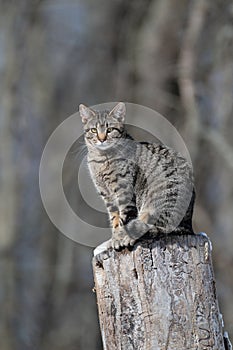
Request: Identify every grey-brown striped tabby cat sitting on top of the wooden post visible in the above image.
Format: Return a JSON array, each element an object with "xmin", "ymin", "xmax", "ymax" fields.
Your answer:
[{"xmin": 79, "ymin": 102, "xmax": 194, "ymax": 249}]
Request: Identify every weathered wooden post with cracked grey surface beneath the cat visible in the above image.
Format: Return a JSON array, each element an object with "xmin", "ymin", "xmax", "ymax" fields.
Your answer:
[{"xmin": 93, "ymin": 234, "xmax": 231, "ymax": 350}]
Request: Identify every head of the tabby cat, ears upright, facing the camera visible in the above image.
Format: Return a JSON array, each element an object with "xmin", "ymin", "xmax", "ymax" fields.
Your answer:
[{"xmin": 79, "ymin": 102, "xmax": 126, "ymax": 150}]
